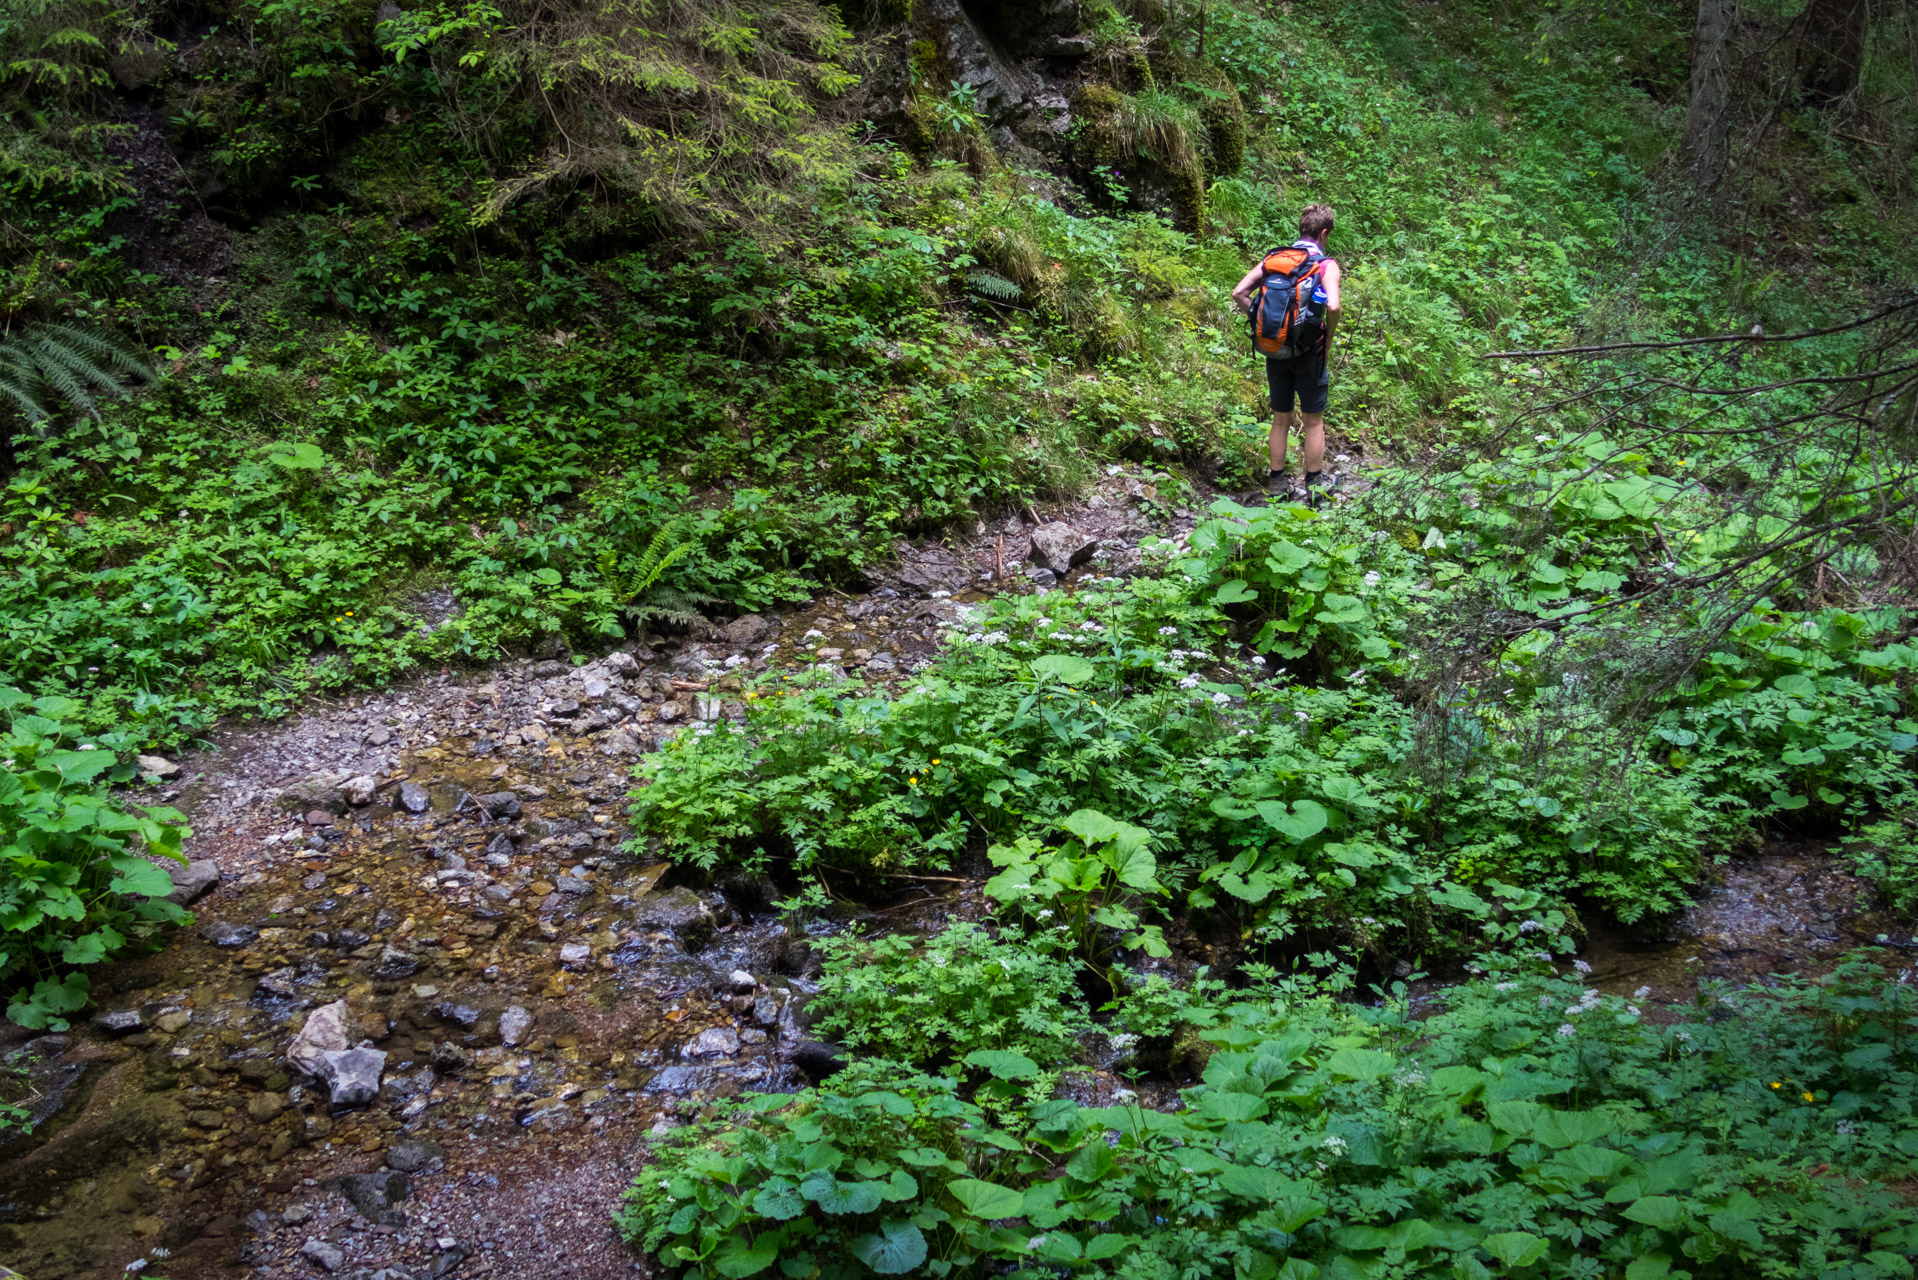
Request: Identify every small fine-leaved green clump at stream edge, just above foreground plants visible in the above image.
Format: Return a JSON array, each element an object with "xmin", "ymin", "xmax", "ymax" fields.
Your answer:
[{"xmin": 813, "ymin": 923, "xmax": 1091, "ymax": 1067}]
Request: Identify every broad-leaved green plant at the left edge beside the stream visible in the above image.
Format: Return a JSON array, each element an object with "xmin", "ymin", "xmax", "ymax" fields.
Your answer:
[{"xmin": 0, "ymin": 687, "xmax": 188, "ymax": 1031}]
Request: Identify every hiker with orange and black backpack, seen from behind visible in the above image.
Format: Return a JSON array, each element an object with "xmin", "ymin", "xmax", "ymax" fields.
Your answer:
[{"xmin": 1231, "ymin": 205, "xmax": 1341, "ymax": 505}]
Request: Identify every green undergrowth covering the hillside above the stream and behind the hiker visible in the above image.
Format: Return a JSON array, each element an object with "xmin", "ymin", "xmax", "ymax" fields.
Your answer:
[{"xmin": 0, "ymin": 0, "xmax": 1903, "ymax": 741}]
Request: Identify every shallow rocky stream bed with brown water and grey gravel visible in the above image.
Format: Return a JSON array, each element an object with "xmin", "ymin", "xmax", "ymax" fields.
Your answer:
[{"xmin": 0, "ymin": 474, "xmax": 1910, "ymax": 1280}]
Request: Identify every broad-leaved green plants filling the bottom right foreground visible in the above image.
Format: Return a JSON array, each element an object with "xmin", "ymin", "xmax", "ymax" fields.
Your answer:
[{"xmin": 621, "ymin": 965, "xmax": 1918, "ymax": 1280}]
